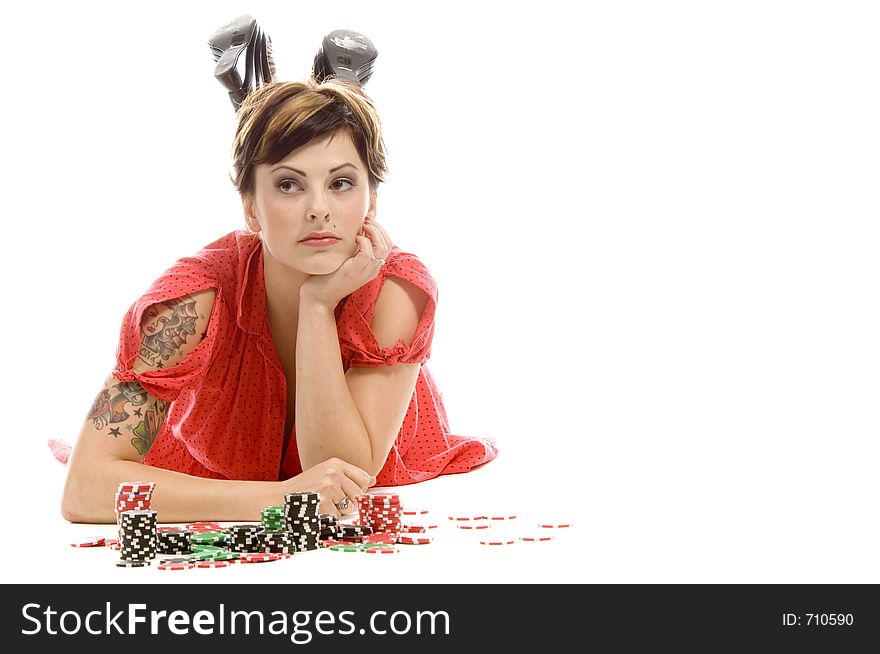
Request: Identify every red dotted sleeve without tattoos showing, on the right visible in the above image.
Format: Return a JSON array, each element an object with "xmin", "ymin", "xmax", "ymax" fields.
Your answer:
[{"xmin": 337, "ymin": 246, "xmax": 437, "ymax": 368}]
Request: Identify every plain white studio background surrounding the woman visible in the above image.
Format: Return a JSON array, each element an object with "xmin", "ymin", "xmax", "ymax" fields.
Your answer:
[{"xmin": 0, "ymin": 0, "xmax": 880, "ymax": 583}]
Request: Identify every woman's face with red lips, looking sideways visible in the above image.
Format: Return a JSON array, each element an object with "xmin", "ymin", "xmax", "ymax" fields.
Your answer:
[{"xmin": 245, "ymin": 132, "xmax": 375, "ymax": 275}]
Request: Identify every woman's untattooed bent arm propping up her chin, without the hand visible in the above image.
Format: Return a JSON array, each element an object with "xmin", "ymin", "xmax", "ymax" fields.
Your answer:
[{"xmin": 296, "ymin": 276, "xmax": 428, "ymax": 475}]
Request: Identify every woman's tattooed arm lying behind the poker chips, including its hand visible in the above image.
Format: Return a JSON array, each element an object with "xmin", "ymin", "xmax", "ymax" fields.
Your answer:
[{"xmin": 61, "ymin": 289, "xmax": 370, "ymax": 522}]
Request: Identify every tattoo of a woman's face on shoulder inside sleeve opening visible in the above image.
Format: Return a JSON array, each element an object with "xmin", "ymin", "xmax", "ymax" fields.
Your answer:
[{"xmin": 138, "ymin": 295, "xmax": 199, "ymax": 369}]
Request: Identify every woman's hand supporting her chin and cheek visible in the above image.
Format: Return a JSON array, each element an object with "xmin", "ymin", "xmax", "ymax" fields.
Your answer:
[{"xmin": 299, "ymin": 220, "xmax": 392, "ymax": 309}]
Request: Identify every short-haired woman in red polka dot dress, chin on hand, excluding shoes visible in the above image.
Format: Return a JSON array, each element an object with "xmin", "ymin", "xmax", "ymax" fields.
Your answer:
[{"xmin": 62, "ymin": 78, "xmax": 497, "ymax": 522}]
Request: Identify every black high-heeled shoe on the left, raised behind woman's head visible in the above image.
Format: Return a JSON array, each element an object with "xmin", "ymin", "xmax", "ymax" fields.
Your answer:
[{"xmin": 208, "ymin": 14, "xmax": 275, "ymax": 111}]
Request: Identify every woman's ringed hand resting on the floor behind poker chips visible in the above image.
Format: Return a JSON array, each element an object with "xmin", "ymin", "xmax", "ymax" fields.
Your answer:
[{"xmin": 281, "ymin": 457, "xmax": 376, "ymax": 517}]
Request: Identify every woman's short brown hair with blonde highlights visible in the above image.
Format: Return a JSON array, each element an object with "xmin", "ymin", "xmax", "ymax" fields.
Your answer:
[{"xmin": 231, "ymin": 78, "xmax": 388, "ymax": 195}]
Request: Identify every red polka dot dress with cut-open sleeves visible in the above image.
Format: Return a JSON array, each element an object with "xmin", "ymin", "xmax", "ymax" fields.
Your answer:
[{"xmin": 114, "ymin": 231, "xmax": 497, "ymax": 486}]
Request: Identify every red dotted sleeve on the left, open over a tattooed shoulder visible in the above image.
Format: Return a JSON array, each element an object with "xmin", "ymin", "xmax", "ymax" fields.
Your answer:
[{"xmin": 113, "ymin": 257, "xmax": 223, "ymax": 402}]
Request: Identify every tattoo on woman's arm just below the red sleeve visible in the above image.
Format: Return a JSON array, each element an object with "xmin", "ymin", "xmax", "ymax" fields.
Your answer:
[{"xmin": 88, "ymin": 377, "xmax": 170, "ymax": 456}]
